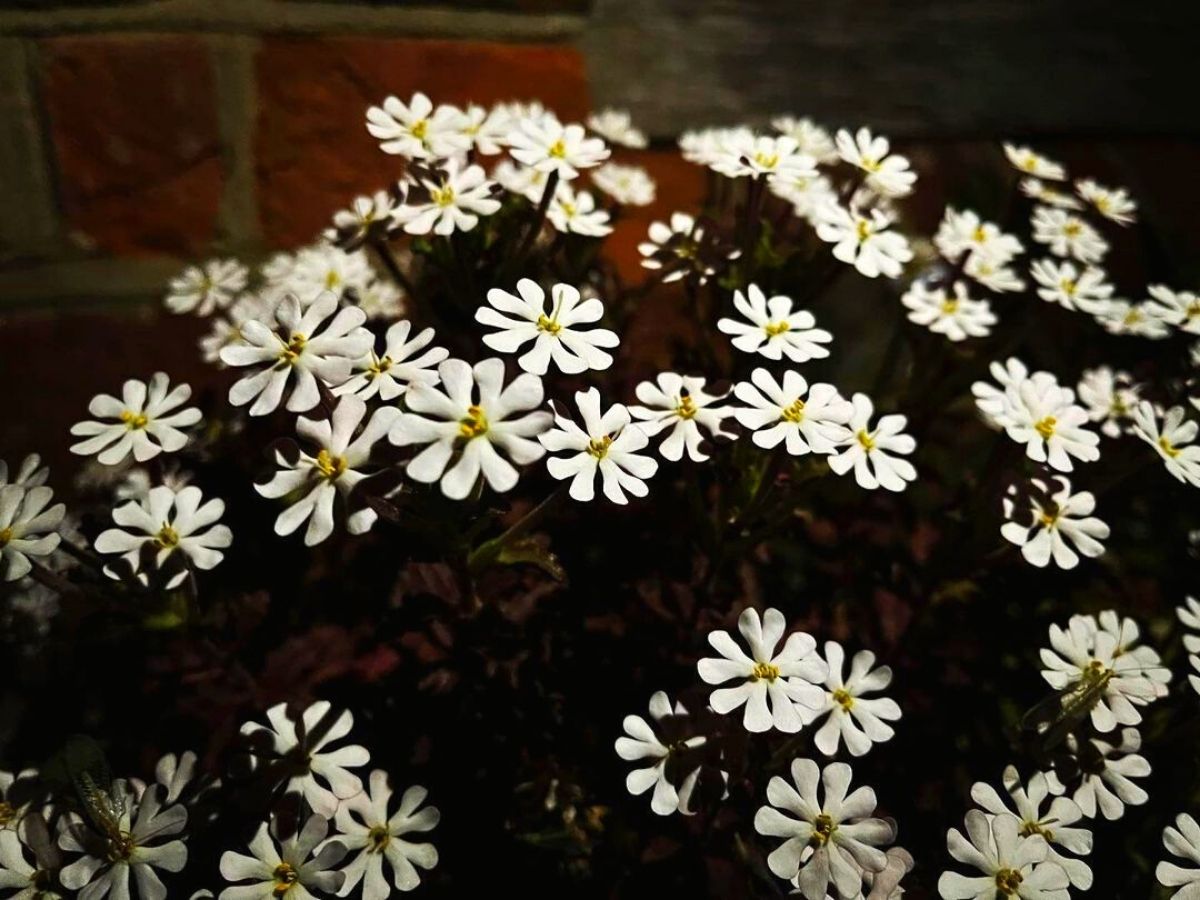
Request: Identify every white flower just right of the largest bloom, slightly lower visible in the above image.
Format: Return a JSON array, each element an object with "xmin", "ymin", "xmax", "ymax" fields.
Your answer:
[{"xmin": 538, "ymin": 388, "xmax": 659, "ymax": 504}]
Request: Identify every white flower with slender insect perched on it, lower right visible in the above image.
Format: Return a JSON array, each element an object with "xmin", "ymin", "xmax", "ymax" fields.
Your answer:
[{"xmin": 1040, "ymin": 616, "xmax": 1159, "ymax": 734}]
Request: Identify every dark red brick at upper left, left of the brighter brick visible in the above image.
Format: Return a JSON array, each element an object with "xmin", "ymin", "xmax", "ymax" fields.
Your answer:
[{"xmin": 41, "ymin": 36, "xmax": 222, "ymax": 256}]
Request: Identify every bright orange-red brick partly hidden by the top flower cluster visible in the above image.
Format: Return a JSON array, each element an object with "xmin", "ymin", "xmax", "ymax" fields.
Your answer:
[{"xmin": 257, "ymin": 38, "xmax": 588, "ymax": 246}]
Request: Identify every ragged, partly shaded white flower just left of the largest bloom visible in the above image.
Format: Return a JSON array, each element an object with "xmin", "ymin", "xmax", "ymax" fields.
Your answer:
[{"xmin": 254, "ymin": 396, "xmax": 401, "ymax": 547}]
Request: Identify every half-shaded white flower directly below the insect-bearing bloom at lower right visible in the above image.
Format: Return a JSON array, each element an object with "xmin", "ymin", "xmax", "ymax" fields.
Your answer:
[{"xmin": 1046, "ymin": 728, "xmax": 1150, "ymax": 821}]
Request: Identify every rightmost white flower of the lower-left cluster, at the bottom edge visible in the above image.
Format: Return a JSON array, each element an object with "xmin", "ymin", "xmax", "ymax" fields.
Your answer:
[{"xmin": 334, "ymin": 769, "xmax": 442, "ymax": 900}]
